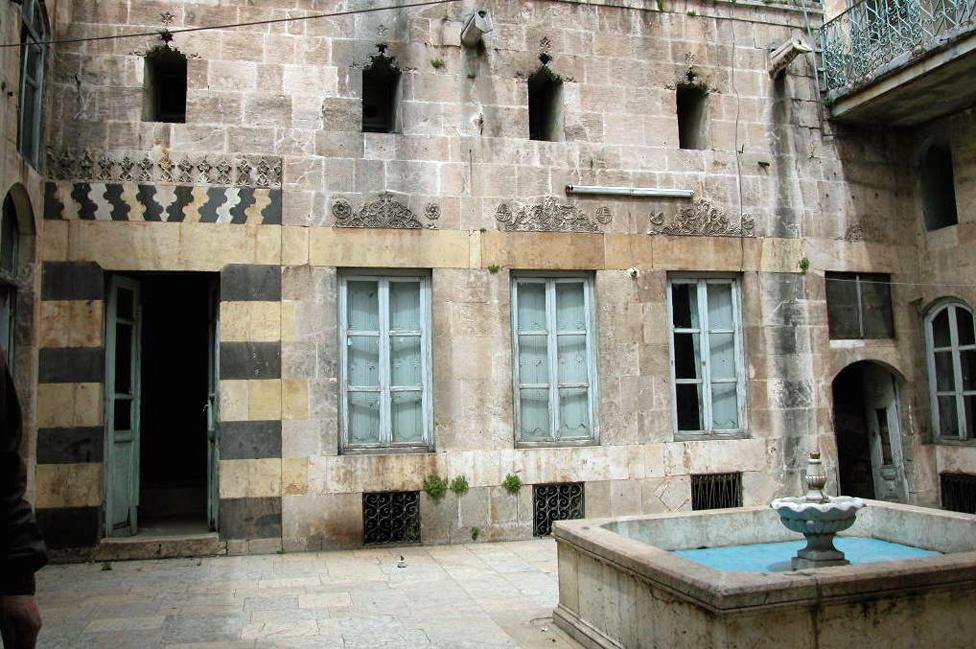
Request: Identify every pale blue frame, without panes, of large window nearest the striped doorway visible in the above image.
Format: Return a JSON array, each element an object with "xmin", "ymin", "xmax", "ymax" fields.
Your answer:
[{"xmin": 338, "ymin": 269, "xmax": 434, "ymax": 454}]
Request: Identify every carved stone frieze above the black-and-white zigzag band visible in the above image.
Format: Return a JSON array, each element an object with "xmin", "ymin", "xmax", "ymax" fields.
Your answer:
[{"xmin": 47, "ymin": 149, "xmax": 282, "ymax": 189}]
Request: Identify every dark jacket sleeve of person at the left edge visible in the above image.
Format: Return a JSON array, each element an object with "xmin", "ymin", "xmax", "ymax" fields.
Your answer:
[{"xmin": 0, "ymin": 356, "xmax": 47, "ymax": 595}]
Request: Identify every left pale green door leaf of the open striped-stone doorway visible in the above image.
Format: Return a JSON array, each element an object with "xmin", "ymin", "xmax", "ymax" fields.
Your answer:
[{"xmin": 105, "ymin": 276, "xmax": 142, "ymax": 536}]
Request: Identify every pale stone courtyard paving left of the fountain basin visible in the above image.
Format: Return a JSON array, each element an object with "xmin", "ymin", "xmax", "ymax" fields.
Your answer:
[{"xmin": 32, "ymin": 539, "xmax": 579, "ymax": 649}]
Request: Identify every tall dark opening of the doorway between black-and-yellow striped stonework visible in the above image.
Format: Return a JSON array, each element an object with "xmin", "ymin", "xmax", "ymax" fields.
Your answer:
[{"xmin": 137, "ymin": 273, "xmax": 215, "ymax": 534}]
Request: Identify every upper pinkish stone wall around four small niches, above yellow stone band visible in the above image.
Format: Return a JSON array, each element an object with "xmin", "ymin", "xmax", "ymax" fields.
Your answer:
[{"xmin": 42, "ymin": 1, "xmax": 920, "ymax": 246}]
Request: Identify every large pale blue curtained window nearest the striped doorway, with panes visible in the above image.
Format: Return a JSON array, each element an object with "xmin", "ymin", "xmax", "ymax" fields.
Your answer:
[{"xmin": 339, "ymin": 274, "xmax": 433, "ymax": 450}]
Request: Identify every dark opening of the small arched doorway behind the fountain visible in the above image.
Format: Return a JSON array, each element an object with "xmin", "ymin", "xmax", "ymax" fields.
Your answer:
[{"xmin": 833, "ymin": 363, "xmax": 875, "ymax": 498}]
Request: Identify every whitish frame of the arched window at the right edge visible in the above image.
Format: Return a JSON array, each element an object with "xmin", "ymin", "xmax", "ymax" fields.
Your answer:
[{"xmin": 924, "ymin": 300, "xmax": 976, "ymax": 442}]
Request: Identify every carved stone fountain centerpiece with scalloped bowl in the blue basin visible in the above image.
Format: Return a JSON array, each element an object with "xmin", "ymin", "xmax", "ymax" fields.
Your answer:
[{"xmin": 769, "ymin": 451, "xmax": 864, "ymax": 570}]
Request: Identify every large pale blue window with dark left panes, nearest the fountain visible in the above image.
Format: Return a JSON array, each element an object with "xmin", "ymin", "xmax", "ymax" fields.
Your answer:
[{"xmin": 668, "ymin": 277, "xmax": 745, "ymax": 435}]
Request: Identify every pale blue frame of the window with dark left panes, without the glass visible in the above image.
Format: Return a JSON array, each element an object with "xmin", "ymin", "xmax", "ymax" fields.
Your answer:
[{"xmin": 667, "ymin": 273, "xmax": 749, "ymax": 441}]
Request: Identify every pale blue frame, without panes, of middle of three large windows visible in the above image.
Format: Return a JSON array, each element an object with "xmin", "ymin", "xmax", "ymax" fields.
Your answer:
[{"xmin": 511, "ymin": 271, "xmax": 600, "ymax": 448}]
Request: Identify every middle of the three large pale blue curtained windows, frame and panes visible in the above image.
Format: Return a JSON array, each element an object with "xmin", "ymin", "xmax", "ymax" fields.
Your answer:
[{"xmin": 512, "ymin": 275, "xmax": 596, "ymax": 445}]
